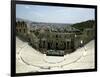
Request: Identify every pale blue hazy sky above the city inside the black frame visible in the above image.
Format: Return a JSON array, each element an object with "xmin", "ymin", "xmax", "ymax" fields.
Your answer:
[{"xmin": 16, "ymin": 4, "xmax": 95, "ymax": 23}]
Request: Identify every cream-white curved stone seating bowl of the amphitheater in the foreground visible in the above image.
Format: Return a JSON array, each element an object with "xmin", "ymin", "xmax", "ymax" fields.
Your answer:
[{"xmin": 16, "ymin": 37, "xmax": 95, "ymax": 73}]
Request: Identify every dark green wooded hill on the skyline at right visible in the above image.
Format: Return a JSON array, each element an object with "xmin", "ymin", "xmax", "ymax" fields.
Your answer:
[{"xmin": 72, "ymin": 20, "xmax": 95, "ymax": 31}]
